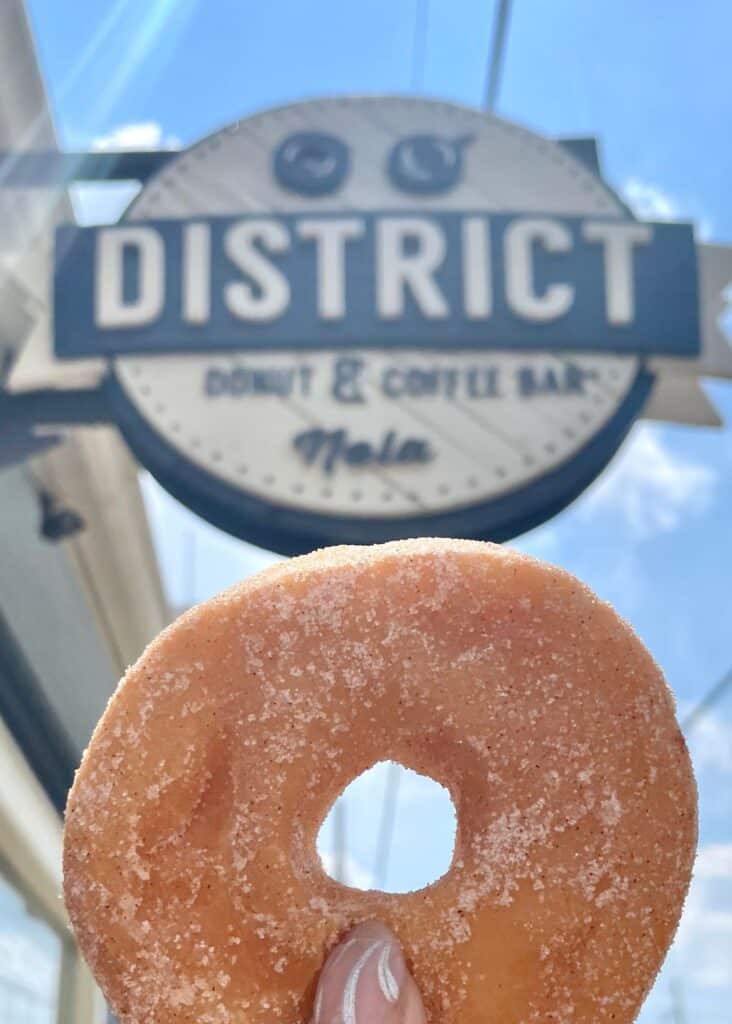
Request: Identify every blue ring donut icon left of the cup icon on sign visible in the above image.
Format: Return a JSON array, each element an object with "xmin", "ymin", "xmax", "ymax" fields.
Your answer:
[{"xmin": 273, "ymin": 131, "xmax": 349, "ymax": 196}]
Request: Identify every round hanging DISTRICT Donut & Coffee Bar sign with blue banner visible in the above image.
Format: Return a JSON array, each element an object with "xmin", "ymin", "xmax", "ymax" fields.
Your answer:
[{"xmin": 38, "ymin": 98, "xmax": 729, "ymax": 552}]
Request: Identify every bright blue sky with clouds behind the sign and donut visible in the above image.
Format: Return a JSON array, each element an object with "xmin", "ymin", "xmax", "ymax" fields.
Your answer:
[{"xmin": 22, "ymin": 0, "xmax": 732, "ymax": 1024}]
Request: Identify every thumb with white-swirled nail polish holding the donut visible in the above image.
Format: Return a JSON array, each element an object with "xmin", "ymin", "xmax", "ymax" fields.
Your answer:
[{"xmin": 312, "ymin": 921, "xmax": 425, "ymax": 1024}]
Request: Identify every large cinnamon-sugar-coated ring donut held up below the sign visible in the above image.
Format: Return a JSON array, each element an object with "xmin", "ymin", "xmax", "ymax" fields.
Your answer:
[{"xmin": 63, "ymin": 540, "xmax": 696, "ymax": 1024}]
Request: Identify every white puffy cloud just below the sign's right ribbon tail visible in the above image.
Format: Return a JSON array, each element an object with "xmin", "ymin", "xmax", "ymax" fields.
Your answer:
[{"xmin": 578, "ymin": 426, "xmax": 717, "ymax": 541}]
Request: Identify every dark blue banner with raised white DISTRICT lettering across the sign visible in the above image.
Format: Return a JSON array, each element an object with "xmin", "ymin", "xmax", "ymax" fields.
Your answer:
[{"xmin": 54, "ymin": 211, "xmax": 699, "ymax": 358}]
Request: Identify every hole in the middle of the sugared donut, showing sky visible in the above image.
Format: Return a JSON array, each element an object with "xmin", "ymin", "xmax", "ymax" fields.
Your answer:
[{"xmin": 317, "ymin": 761, "xmax": 457, "ymax": 893}]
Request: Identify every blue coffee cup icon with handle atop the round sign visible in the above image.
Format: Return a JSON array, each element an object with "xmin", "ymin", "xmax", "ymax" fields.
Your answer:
[{"xmin": 387, "ymin": 135, "xmax": 474, "ymax": 196}]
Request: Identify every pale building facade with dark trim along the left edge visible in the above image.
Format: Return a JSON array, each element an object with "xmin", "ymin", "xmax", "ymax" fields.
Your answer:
[{"xmin": 0, "ymin": 0, "xmax": 167, "ymax": 1024}]
